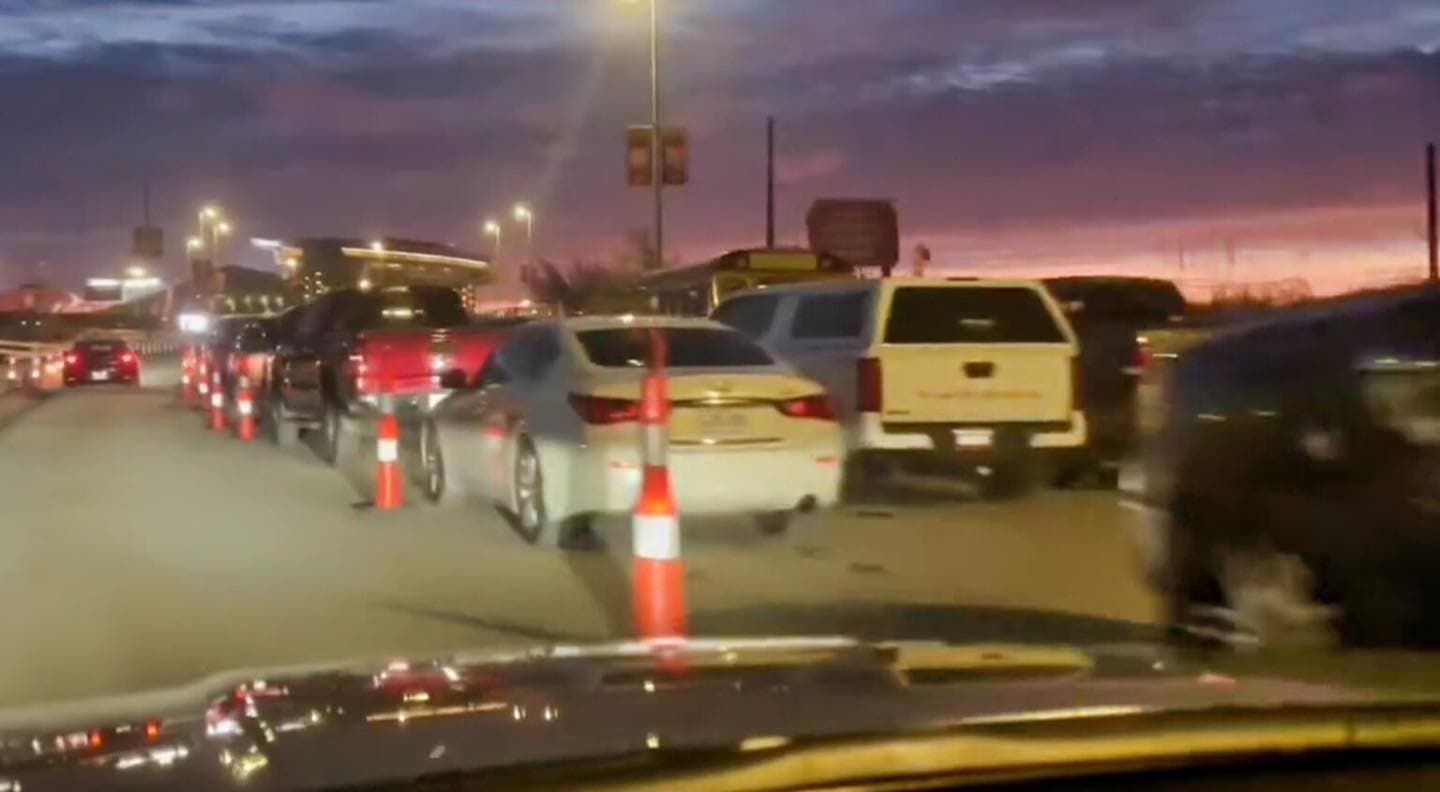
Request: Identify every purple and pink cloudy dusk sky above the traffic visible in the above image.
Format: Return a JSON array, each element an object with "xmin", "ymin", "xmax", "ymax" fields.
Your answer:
[{"xmin": 0, "ymin": 0, "xmax": 1440, "ymax": 298}]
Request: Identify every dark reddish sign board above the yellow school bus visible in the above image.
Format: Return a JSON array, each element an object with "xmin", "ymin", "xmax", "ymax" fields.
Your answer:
[{"xmin": 805, "ymin": 199, "xmax": 900, "ymax": 278}]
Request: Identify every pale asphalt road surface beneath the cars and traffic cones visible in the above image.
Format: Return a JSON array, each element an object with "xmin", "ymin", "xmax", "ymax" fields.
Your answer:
[{"xmin": 0, "ymin": 361, "xmax": 1155, "ymax": 707}]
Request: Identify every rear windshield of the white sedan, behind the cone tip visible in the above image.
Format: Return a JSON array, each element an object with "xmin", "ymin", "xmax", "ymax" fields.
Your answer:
[{"xmin": 576, "ymin": 327, "xmax": 773, "ymax": 369}]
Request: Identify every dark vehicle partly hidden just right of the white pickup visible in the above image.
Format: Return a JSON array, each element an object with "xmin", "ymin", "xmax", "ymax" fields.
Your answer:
[{"xmin": 1045, "ymin": 275, "xmax": 1187, "ymax": 485}]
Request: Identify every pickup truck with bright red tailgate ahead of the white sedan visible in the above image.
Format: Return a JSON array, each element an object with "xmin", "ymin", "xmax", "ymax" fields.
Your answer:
[{"xmin": 261, "ymin": 285, "xmax": 503, "ymax": 462}]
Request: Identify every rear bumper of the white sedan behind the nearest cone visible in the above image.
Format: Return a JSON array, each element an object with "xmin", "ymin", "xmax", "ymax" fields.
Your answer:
[{"xmin": 555, "ymin": 444, "xmax": 844, "ymax": 514}]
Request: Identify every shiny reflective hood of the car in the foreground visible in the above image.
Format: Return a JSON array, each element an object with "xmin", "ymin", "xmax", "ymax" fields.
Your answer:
[{"xmin": 0, "ymin": 638, "xmax": 1440, "ymax": 789}]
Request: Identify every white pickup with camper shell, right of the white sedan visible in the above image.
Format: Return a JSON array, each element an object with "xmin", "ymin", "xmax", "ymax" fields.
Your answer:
[{"xmin": 713, "ymin": 278, "xmax": 1086, "ymax": 497}]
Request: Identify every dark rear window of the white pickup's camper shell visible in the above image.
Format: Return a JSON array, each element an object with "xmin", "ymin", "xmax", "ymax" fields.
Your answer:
[{"xmin": 886, "ymin": 287, "xmax": 1066, "ymax": 344}]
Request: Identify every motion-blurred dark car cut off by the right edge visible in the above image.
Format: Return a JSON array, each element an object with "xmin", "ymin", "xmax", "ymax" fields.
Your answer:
[{"xmin": 1138, "ymin": 287, "xmax": 1440, "ymax": 645}]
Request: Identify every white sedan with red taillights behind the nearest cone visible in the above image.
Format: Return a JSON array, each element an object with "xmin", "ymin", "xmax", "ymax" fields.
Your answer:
[{"xmin": 416, "ymin": 317, "xmax": 844, "ymax": 544}]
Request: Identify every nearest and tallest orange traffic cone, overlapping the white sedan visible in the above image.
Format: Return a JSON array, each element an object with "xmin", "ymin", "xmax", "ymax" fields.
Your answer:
[{"xmin": 631, "ymin": 331, "xmax": 685, "ymax": 641}]
